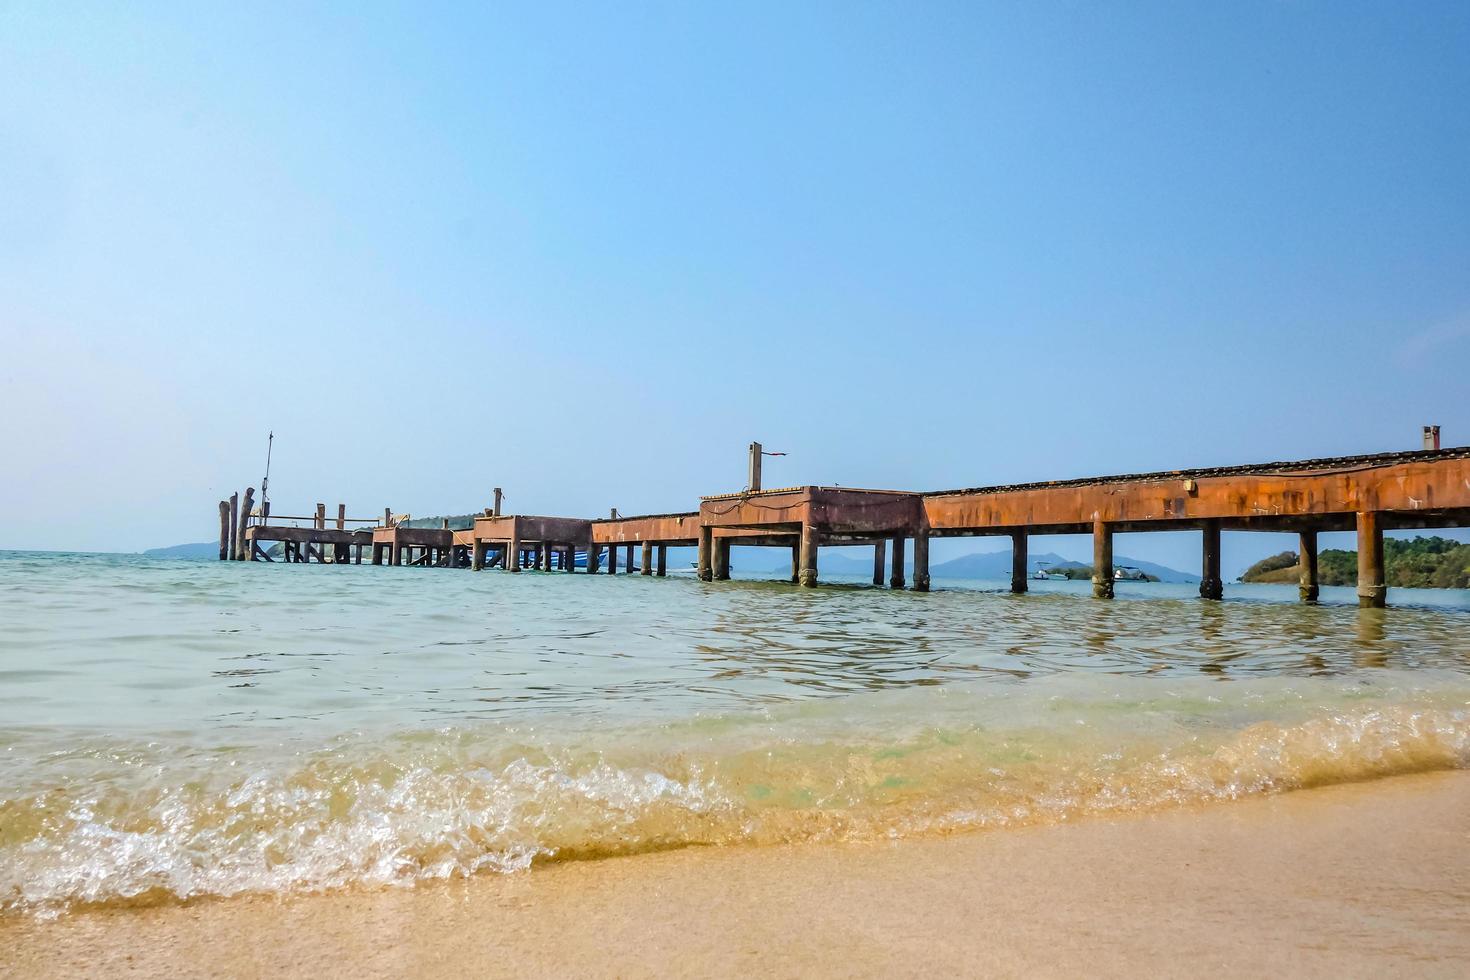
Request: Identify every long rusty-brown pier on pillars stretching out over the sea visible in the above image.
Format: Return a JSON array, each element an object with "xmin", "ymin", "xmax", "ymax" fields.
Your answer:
[{"xmin": 219, "ymin": 444, "xmax": 1470, "ymax": 607}]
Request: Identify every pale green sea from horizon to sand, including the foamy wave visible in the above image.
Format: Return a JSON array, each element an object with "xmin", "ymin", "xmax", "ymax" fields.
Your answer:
[{"xmin": 0, "ymin": 554, "xmax": 1470, "ymax": 914}]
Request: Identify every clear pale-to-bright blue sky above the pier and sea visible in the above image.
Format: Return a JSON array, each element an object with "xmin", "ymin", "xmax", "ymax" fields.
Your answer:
[{"xmin": 0, "ymin": 1, "xmax": 1470, "ymax": 570}]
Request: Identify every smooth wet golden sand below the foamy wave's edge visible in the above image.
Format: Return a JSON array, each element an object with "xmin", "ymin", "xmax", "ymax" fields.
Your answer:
[{"xmin": 0, "ymin": 773, "xmax": 1470, "ymax": 977}]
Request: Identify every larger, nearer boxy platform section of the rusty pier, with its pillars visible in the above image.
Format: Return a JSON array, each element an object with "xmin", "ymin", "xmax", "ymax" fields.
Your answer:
[{"xmin": 698, "ymin": 486, "xmax": 929, "ymax": 592}]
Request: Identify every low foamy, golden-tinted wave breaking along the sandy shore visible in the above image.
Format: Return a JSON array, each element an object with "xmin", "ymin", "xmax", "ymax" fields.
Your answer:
[{"xmin": 0, "ymin": 671, "xmax": 1470, "ymax": 915}]
